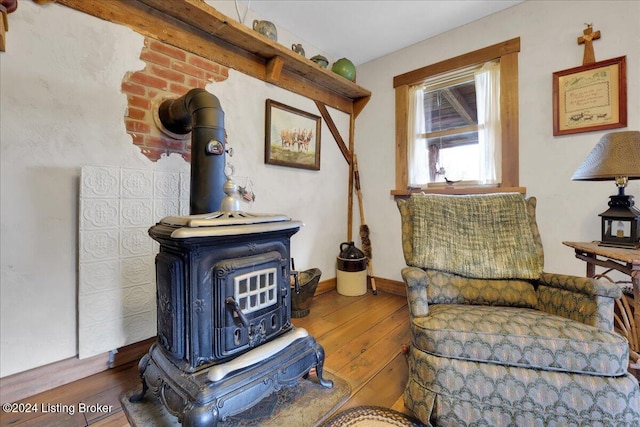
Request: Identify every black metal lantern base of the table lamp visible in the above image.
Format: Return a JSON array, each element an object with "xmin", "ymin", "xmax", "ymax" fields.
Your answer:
[{"xmin": 600, "ymin": 191, "xmax": 640, "ymax": 248}]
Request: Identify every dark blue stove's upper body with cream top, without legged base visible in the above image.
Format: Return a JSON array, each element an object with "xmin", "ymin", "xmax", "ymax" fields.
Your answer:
[{"xmin": 149, "ymin": 213, "xmax": 300, "ymax": 372}]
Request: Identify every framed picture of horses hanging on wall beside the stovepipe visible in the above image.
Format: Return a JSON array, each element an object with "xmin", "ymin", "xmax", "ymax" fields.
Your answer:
[{"xmin": 264, "ymin": 99, "xmax": 322, "ymax": 170}]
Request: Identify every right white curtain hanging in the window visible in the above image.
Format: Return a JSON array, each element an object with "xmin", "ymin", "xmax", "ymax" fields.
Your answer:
[{"xmin": 475, "ymin": 62, "xmax": 502, "ymax": 184}]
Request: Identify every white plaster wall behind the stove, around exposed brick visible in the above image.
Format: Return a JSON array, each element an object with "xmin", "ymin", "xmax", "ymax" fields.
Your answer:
[{"xmin": 0, "ymin": 1, "xmax": 349, "ymax": 377}]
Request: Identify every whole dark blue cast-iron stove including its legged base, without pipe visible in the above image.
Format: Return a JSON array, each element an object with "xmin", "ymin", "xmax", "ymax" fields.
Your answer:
[{"xmin": 130, "ymin": 211, "xmax": 333, "ymax": 427}]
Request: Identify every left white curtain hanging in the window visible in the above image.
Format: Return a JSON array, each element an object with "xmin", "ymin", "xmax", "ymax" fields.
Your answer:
[{"xmin": 407, "ymin": 86, "xmax": 429, "ymax": 187}]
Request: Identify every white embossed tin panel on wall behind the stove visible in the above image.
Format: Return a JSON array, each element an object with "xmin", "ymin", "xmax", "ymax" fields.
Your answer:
[{"xmin": 78, "ymin": 166, "xmax": 189, "ymax": 358}]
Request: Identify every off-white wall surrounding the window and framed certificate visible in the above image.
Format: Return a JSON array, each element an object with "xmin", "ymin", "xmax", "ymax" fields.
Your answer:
[{"xmin": 356, "ymin": 0, "xmax": 640, "ymax": 280}]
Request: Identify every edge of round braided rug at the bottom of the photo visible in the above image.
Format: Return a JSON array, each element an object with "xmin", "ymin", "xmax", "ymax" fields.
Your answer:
[{"xmin": 322, "ymin": 406, "xmax": 425, "ymax": 427}]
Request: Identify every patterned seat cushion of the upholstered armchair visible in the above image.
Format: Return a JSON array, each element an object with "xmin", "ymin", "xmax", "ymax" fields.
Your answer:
[{"xmin": 411, "ymin": 304, "xmax": 629, "ymax": 376}]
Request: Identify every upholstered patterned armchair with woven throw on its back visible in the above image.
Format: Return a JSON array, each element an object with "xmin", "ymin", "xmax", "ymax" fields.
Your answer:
[{"xmin": 398, "ymin": 193, "xmax": 640, "ymax": 427}]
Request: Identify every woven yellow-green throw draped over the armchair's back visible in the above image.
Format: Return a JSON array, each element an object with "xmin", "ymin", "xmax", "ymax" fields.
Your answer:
[{"xmin": 409, "ymin": 193, "xmax": 543, "ymax": 279}]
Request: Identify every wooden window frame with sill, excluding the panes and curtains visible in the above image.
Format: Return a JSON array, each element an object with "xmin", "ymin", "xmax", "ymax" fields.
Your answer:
[{"xmin": 391, "ymin": 37, "xmax": 526, "ymax": 196}]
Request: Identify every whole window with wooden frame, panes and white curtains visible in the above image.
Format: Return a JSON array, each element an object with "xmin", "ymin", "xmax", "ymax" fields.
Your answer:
[{"xmin": 393, "ymin": 39, "xmax": 521, "ymax": 195}]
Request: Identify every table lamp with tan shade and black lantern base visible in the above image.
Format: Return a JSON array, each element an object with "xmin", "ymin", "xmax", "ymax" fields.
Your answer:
[{"xmin": 571, "ymin": 131, "xmax": 640, "ymax": 248}]
